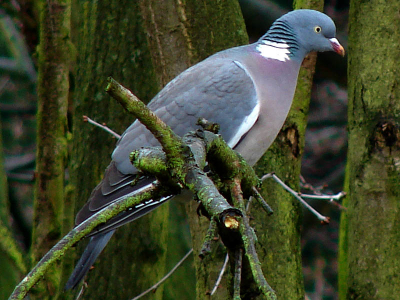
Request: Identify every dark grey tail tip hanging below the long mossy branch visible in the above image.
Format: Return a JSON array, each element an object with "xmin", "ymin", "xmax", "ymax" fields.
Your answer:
[{"xmin": 65, "ymin": 230, "xmax": 115, "ymax": 290}]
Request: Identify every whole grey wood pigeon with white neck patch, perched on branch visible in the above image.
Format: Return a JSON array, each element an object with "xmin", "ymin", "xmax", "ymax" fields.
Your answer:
[{"xmin": 66, "ymin": 9, "xmax": 344, "ymax": 289}]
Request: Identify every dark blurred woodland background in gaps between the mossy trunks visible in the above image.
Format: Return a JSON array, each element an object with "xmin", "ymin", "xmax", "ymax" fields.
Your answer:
[{"xmin": 0, "ymin": 0, "xmax": 349, "ymax": 299}]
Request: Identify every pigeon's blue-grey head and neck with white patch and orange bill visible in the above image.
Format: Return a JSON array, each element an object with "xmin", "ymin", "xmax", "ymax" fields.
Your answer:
[{"xmin": 258, "ymin": 9, "xmax": 344, "ymax": 61}]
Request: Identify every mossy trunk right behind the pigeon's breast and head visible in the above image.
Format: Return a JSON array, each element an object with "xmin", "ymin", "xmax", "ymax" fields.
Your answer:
[{"xmin": 251, "ymin": 0, "xmax": 324, "ymax": 300}]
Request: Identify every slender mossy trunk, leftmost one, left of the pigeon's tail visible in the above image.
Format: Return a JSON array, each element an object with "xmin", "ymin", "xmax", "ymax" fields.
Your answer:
[{"xmin": 32, "ymin": 0, "xmax": 71, "ymax": 299}]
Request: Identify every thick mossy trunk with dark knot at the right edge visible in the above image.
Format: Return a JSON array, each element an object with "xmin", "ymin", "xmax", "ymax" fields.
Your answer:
[{"xmin": 339, "ymin": 0, "xmax": 400, "ymax": 299}]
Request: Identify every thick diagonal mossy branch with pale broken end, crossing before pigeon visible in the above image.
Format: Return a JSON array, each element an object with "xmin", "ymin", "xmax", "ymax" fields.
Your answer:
[{"xmin": 106, "ymin": 77, "xmax": 241, "ymax": 229}]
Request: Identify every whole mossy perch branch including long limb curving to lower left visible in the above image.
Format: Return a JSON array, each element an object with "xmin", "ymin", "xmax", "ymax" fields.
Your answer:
[{"xmin": 9, "ymin": 78, "xmax": 276, "ymax": 299}]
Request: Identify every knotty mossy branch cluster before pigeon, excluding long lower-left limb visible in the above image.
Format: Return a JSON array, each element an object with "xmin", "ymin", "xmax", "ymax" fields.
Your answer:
[{"xmin": 107, "ymin": 79, "xmax": 276, "ymax": 299}]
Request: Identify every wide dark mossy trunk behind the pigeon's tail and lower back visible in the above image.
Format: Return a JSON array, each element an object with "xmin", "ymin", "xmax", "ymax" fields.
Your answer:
[{"xmin": 64, "ymin": 0, "xmax": 168, "ymax": 299}]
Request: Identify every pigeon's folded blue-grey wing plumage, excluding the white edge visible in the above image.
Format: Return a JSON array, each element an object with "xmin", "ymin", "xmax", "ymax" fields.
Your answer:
[{"xmin": 112, "ymin": 56, "xmax": 257, "ymax": 174}]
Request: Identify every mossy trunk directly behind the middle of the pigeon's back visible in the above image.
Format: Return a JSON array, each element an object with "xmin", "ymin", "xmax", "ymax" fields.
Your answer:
[{"xmin": 141, "ymin": 0, "xmax": 248, "ymax": 299}]
